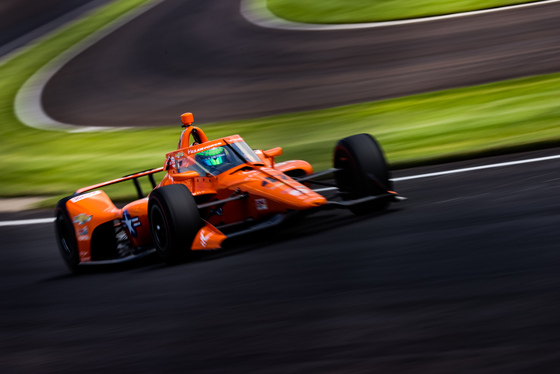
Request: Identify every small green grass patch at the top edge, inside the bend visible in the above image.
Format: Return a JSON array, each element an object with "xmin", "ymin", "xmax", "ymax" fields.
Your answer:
[{"xmin": 266, "ymin": 0, "xmax": 537, "ymax": 24}]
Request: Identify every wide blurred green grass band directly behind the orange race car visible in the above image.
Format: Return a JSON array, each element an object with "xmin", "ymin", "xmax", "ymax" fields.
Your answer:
[{"xmin": 0, "ymin": 0, "xmax": 560, "ymax": 204}]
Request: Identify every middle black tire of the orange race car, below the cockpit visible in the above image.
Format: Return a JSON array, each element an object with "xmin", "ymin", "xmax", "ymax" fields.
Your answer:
[{"xmin": 148, "ymin": 184, "xmax": 203, "ymax": 265}]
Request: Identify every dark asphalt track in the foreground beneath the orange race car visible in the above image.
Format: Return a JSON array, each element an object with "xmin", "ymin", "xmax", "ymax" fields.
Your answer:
[{"xmin": 0, "ymin": 149, "xmax": 560, "ymax": 374}]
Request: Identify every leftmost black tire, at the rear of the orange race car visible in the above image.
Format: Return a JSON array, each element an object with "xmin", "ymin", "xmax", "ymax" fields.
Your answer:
[{"xmin": 54, "ymin": 202, "xmax": 80, "ymax": 272}]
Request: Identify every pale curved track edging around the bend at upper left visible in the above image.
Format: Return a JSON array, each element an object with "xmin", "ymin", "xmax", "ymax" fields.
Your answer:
[{"xmin": 14, "ymin": 0, "xmax": 163, "ymax": 132}]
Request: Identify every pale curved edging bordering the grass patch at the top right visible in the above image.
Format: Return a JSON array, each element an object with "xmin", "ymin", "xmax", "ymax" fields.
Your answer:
[{"xmin": 240, "ymin": 0, "xmax": 560, "ymax": 31}]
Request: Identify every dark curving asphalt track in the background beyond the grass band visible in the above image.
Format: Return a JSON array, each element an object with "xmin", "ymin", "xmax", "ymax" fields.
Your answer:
[{"xmin": 43, "ymin": 0, "xmax": 560, "ymax": 126}]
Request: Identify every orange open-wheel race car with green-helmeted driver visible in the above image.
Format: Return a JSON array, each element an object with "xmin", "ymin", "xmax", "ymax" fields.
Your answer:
[{"xmin": 55, "ymin": 113, "xmax": 404, "ymax": 270}]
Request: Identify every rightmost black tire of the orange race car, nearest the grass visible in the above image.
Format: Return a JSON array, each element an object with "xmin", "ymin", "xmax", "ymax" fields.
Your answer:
[{"xmin": 334, "ymin": 134, "xmax": 393, "ymax": 214}]
